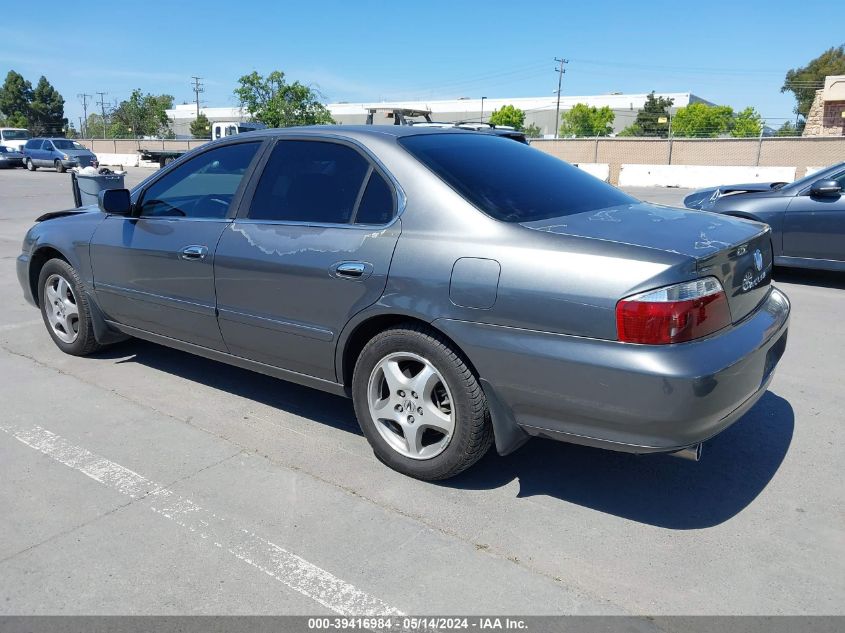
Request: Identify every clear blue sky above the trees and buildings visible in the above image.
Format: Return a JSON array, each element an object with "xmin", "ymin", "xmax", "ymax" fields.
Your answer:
[{"xmin": 0, "ymin": 0, "xmax": 845, "ymax": 127}]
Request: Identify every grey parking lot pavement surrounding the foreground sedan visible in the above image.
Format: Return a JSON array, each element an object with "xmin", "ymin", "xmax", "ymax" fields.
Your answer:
[{"xmin": 0, "ymin": 169, "xmax": 845, "ymax": 615}]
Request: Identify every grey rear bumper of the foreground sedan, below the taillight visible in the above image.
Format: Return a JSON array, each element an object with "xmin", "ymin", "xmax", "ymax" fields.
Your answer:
[{"xmin": 435, "ymin": 288, "xmax": 790, "ymax": 453}]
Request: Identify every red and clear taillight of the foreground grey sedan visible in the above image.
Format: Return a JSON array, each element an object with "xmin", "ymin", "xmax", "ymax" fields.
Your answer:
[{"xmin": 616, "ymin": 277, "xmax": 731, "ymax": 345}]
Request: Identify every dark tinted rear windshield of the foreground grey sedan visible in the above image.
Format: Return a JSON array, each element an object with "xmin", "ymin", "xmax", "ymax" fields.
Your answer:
[{"xmin": 399, "ymin": 133, "xmax": 638, "ymax": 222}]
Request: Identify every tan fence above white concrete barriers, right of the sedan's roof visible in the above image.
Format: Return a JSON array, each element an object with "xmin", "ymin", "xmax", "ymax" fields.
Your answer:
[{"xmin": 531, "ymin": 136, "xmax": 845, "ymax": 183}]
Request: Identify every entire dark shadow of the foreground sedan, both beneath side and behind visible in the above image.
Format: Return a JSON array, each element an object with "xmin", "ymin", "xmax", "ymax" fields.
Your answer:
[{"xmin": 97, "ymin": 340, "xmax": 795, "ymax": 530}]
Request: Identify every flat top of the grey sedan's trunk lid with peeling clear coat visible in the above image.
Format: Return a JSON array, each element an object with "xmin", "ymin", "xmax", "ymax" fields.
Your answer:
[{"xmin": 522, "ymin": 203, "xmax": 765, "ymax": 259}]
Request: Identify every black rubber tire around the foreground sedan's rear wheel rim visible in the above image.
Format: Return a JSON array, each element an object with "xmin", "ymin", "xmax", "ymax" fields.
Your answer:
[{"xmin": 352, "ymin": 323, "xmax": 493, "ymax": 481}]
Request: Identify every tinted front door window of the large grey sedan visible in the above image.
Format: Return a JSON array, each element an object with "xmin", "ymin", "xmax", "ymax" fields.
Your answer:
[{"xmin": 138, "ymin": 141, "xmax": 261, "ymax": 218}]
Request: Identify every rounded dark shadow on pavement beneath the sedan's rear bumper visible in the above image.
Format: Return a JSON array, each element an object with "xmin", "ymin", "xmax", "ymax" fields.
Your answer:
[{"xmin": 440, "ymin": 392, "xmax": 795, "ymax": 530}]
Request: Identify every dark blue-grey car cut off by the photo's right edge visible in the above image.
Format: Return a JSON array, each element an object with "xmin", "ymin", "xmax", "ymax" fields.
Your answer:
[{"xmin": 684, "ymin": 162, "xmax": 845, "ymax": 271}]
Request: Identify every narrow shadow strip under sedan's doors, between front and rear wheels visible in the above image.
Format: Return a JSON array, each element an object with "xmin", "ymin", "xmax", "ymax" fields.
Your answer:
[{"xmin": 97, "ymin": 339, "xmax": 363, "ymax": 436}]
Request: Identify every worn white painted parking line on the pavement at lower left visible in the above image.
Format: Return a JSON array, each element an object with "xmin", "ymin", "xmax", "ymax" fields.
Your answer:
[{"xmin": 0, "ymin": 424, "xmax": 403, "ymax": 616}]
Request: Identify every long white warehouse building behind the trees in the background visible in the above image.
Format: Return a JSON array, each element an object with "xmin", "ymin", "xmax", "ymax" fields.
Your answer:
[{"xmin": 167, "ymin": 92, "xmax": 712, "ymax": 138}]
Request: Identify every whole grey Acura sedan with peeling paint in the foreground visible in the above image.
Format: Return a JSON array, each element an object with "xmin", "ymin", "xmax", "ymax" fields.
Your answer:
[{"xmin": 17, "ymin": 125, "xmax": 790, "ymax": 480}]
